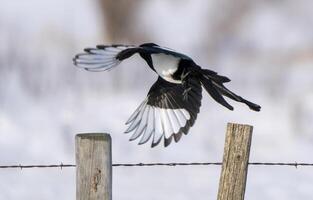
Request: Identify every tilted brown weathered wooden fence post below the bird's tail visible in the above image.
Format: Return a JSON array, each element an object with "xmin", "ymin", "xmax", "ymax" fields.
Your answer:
[{"xmin": 217, "ymin": 123, "xmax": 253, "ymax": 200}]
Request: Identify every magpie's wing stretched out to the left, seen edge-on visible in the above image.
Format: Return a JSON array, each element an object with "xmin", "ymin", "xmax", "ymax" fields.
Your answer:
[{"xmin": 73, "ymin": 45, "xmax": 140, "ymax": 72}]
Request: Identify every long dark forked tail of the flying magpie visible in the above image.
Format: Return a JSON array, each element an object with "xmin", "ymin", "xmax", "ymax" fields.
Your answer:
[{"xmin": 200, "ymin": 69, "xmax": 261, "ymax": 111}]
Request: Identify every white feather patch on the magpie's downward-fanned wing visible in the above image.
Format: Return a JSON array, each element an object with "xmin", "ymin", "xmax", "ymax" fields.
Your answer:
[{"xmin": 125, "ymin": 99, "xmax": 190, "ymax": 146}]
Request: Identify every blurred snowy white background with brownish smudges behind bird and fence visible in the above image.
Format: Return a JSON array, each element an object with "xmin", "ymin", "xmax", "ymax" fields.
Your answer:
[{"xmin": 0, "ymin": 0, "xmax": 313, "ymax": 200}]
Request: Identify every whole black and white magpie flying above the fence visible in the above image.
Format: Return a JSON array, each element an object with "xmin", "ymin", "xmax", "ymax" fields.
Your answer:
[{"xmin": 73, "ymin": 43, "xmax": 261, "ymax": 147}]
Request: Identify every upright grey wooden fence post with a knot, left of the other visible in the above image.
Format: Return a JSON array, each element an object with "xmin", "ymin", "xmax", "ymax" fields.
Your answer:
[{"xmin": 75, "ymin": 133, "xmax": 112, "ymax": 200}]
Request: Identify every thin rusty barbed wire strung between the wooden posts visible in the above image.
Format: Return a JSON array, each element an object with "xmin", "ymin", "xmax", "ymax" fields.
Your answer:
[{"xmin": 0, "ymin": 162, "xmax": 313, "ymax": 170}]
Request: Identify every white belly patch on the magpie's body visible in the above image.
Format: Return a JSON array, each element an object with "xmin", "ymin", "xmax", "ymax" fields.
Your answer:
[{"xmin": 151, "ymin": 53, "xmax": 181, "ymax": 83}]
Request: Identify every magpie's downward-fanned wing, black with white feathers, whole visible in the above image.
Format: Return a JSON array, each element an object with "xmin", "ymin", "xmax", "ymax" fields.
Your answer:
[{"xmin": 125, "ymin": 77, "xmax": 202, "ymax": 147}]
